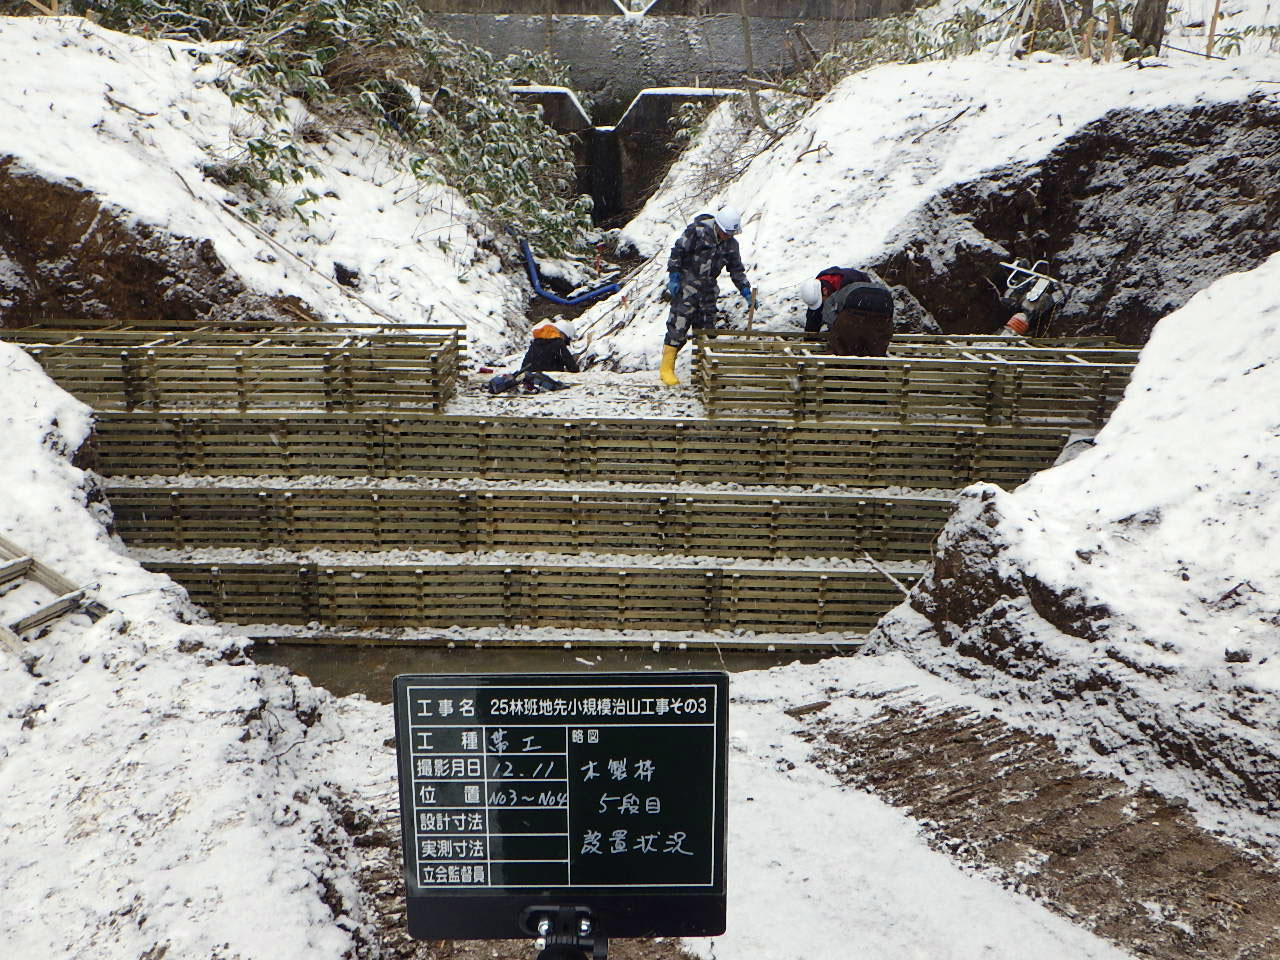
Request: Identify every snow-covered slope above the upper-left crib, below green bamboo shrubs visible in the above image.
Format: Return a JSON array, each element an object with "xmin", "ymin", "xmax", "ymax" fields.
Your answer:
[{"xmin": 0, "ymin": 17, "xmax": 527, "ymax": 355}]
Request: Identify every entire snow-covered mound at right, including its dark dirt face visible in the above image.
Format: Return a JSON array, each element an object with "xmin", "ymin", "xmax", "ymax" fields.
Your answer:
[{"xmin": 878, "ymin": 253, "xmax": 1280, "ymax": 842}]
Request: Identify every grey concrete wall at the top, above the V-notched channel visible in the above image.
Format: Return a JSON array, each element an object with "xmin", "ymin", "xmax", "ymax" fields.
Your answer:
[{"xmin": 430, "ymin": 13, "xmax": 865, "ymax": 124}]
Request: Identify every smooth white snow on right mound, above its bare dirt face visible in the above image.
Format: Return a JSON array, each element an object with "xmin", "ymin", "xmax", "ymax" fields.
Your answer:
[{"xmin": 1014, "ymin": 255, "xmax": 1280, "ymax": 680}]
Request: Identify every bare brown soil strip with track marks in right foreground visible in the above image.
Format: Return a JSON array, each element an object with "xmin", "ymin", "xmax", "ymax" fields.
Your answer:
[{"xmin": 809, "ymin": 704, "xmax": 1280, "ymax": 960}]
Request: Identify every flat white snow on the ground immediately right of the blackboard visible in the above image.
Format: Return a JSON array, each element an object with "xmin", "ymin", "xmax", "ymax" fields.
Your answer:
[{"xmin": 691, "ymin": 657, "xmax": 1128, "ymax": 960}]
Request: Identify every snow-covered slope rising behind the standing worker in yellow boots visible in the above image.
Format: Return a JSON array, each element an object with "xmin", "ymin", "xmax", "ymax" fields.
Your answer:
[{"xmin": 580, "ymin": 54, "xmax": 1275, "ymax": 369}]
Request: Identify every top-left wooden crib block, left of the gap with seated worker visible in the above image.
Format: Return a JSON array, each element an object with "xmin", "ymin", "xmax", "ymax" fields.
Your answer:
[{"xmin": 0, "ymin": 323, "xmax": 463, "ymax": 412}]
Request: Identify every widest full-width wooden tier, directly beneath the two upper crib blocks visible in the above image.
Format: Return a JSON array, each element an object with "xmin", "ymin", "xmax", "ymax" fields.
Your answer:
[{"xmin": 90, "ymin": 411, "xmax": 1071, "ymax": 489}]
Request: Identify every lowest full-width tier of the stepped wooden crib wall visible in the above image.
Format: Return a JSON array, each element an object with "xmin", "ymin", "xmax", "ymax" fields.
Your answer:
[{"xmin": 146, "ymin": 562, "xmax": 918, "ymax": 632}]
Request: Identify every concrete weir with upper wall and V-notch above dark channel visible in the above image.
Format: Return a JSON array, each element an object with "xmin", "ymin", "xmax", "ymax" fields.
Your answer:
[{"xmin": 421, "ymin": 0, "xmax": 914, "ymax": 223}]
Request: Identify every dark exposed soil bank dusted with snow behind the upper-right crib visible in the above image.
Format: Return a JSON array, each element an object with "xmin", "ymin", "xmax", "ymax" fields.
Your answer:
[{"xmin": 873, "ymin": 95, "xmax": 1280, "ymax": 343}]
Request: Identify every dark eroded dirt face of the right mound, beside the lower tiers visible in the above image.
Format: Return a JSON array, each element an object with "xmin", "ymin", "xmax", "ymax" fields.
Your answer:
[{"xmin": 869, "ymin": 488, "xmax": 1280, "ymax": 834}]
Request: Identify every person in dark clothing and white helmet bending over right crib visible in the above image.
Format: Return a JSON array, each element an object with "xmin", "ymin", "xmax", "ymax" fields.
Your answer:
[{"xmin": 800, "ymin": 266, "xmax": 893, "ymax": 357}]
